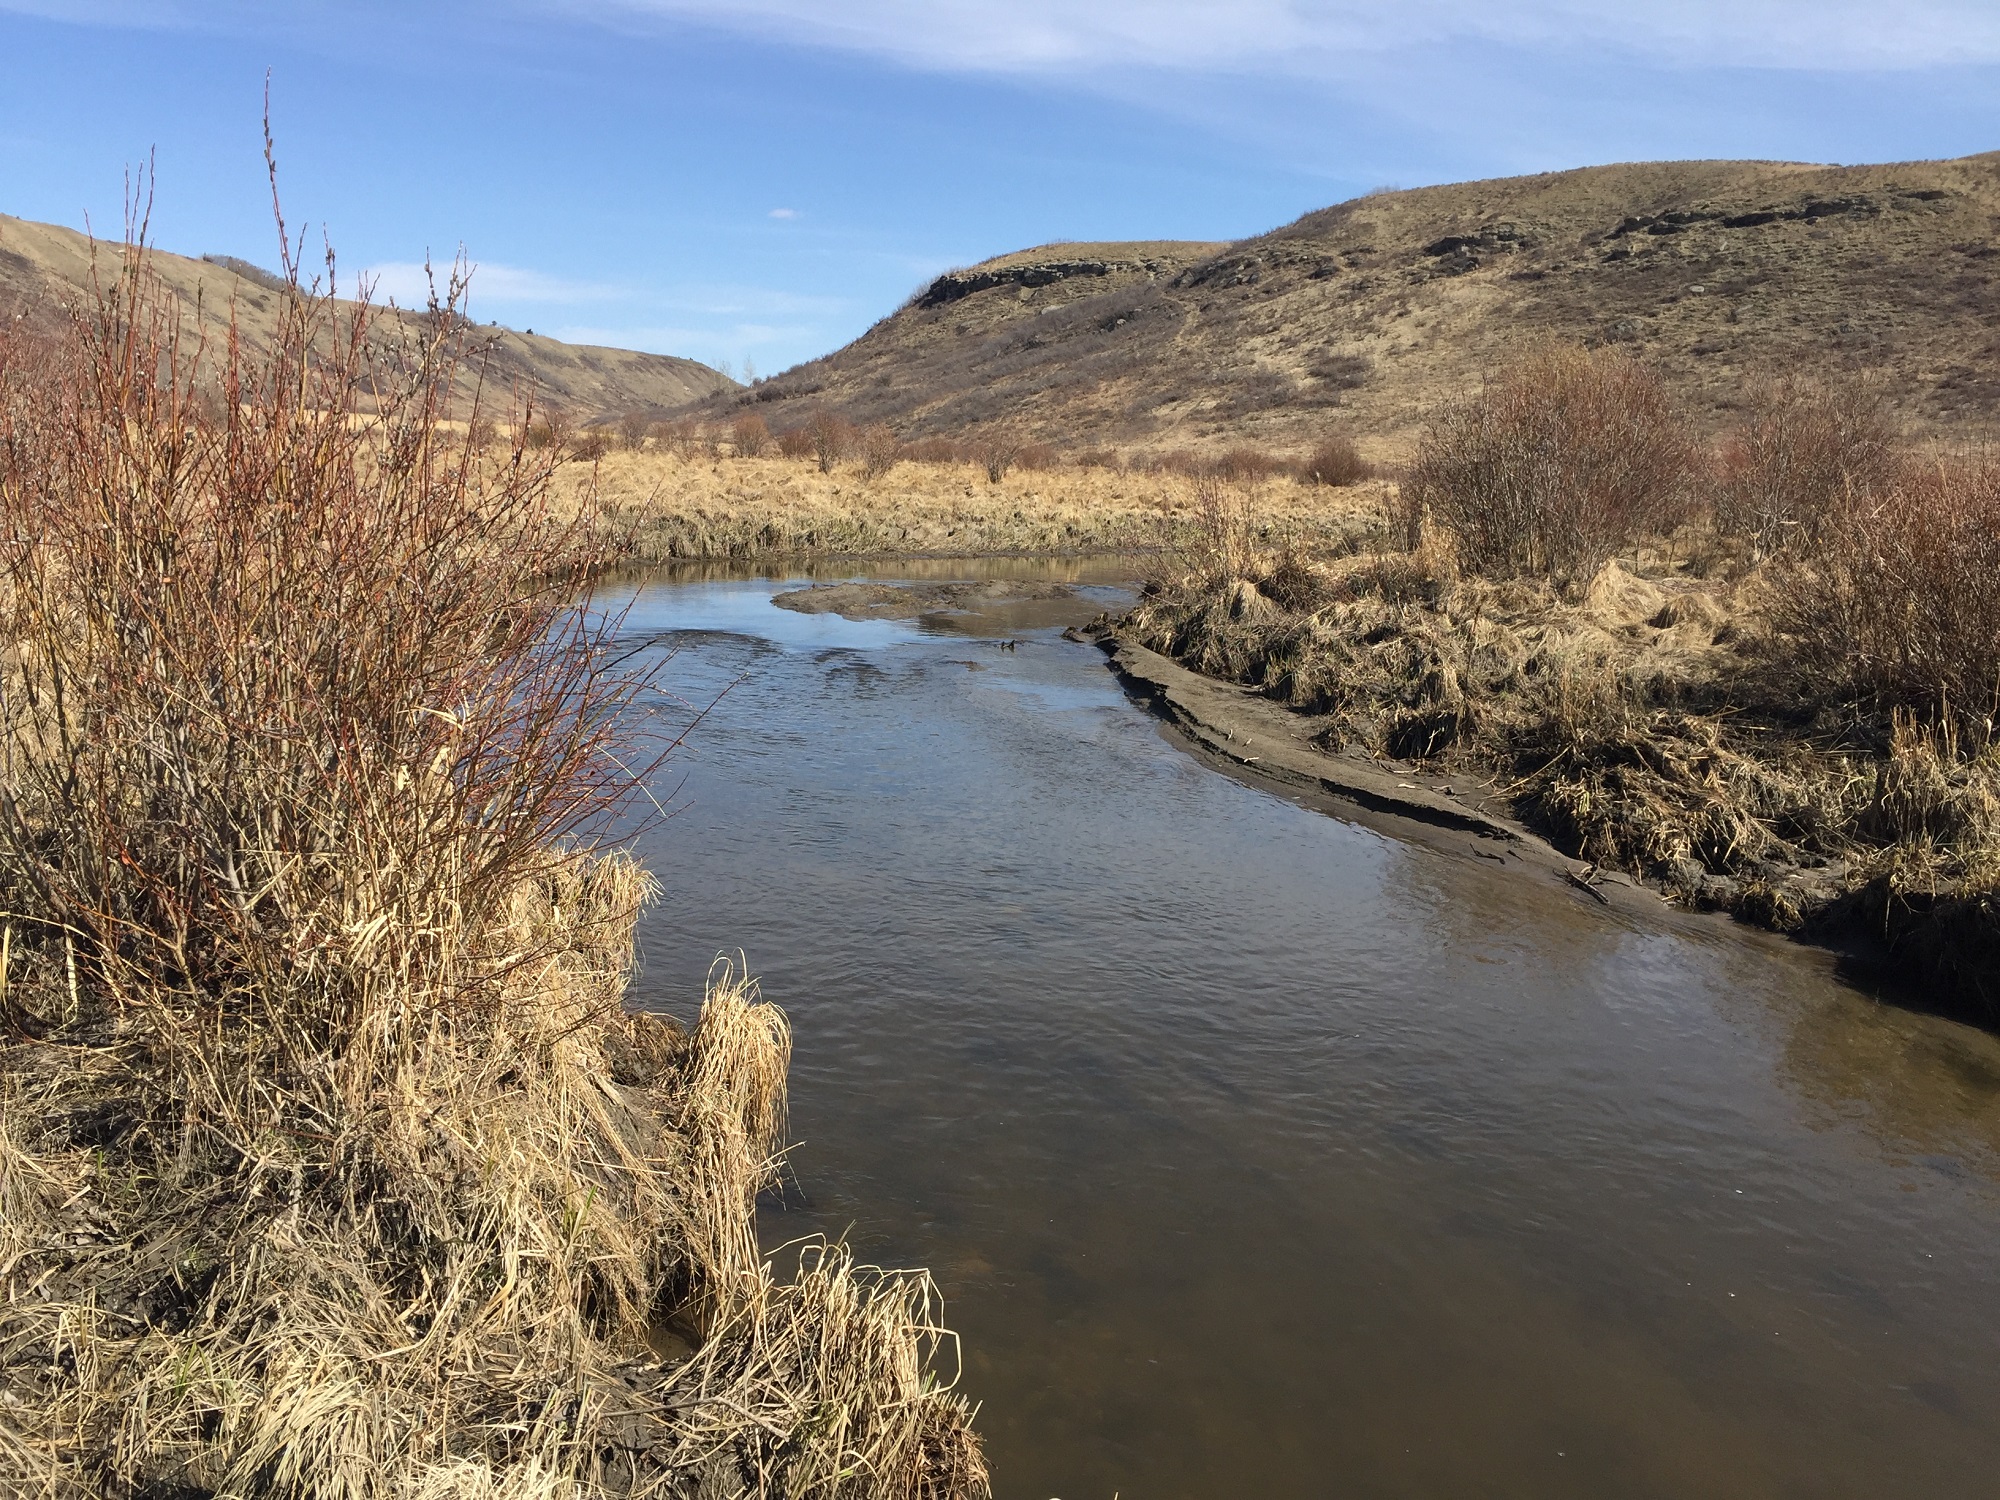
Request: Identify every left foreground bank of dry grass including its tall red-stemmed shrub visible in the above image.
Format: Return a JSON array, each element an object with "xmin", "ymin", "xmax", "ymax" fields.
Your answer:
[{"xmin": 0, "ymin": 241, "xmax": 986, "ymax": 1500}]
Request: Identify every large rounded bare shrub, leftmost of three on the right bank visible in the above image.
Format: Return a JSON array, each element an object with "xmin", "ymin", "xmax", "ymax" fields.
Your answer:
[{"xmin": 1398, "ymin": 348, "xmax": 1696, "ymax": 580}]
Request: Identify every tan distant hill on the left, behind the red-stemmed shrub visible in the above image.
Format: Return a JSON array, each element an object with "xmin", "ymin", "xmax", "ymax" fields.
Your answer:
[{"xmin": 0, "ymin": 214, "xmax": 738, "ymax": 422}]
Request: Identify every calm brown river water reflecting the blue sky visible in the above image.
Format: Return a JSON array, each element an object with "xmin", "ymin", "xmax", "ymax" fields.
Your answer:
[{"xmin": 630, "ymin": 566, "xmax": 2000, "ymax": 1500}]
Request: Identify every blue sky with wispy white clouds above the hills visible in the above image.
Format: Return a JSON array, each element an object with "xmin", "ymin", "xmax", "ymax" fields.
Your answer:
[{"xmin": 0, "ymin": 0, "xmax": 2000, "ymax": 374}]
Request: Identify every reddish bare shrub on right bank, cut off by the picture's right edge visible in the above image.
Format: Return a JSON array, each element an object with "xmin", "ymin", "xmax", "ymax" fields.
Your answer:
[{"xmin": 1772, "ymin": 458, "xmax": 2000, "ymax": 744}]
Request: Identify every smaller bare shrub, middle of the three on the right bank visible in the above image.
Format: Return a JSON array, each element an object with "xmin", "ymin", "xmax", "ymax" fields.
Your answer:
[{"xmin": 1716, "ymin": 376, "xmax": 1896, "ymax": 554}]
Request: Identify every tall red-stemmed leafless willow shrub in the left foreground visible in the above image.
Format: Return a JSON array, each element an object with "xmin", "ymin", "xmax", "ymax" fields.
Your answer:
[{"xmin": 0, "ymin": 223, "xmax": 664, "ymax": 1076}]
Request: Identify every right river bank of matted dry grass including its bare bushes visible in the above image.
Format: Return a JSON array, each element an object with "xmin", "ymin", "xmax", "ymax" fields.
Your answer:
[{"xmin": 1122, "ymin": 356, "xmax": 2000, "ymax": 1022}]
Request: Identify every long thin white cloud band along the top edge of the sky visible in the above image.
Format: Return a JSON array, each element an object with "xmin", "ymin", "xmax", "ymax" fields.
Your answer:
[{"xmin": 584, "ymin": 0, "xmax": 2000, "ymax": 74}]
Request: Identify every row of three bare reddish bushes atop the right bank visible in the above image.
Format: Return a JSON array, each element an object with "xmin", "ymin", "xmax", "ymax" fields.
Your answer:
[{"xmin": 1396, "ymin": 348, "xmax": 2000, "ymax": 744}]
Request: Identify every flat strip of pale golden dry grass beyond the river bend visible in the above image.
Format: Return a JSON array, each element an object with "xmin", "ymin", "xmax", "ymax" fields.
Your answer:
[{"xmin": 556, "ymin": 448, "xmax": 1386, "ymax": 564}]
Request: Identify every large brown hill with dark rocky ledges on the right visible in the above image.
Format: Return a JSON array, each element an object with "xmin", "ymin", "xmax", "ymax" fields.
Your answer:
[{"xmin": 710, "ymin": 152, "xmax": 2000, "ymax": 462}]
